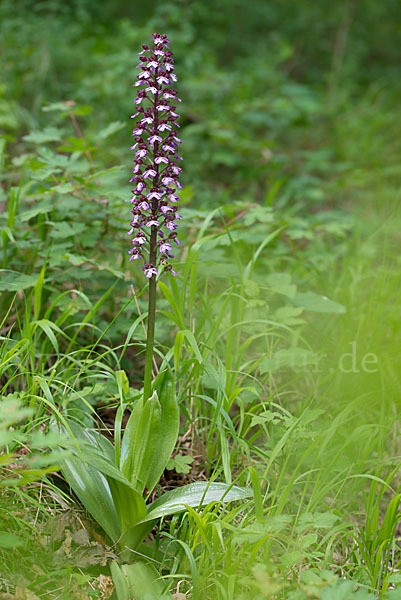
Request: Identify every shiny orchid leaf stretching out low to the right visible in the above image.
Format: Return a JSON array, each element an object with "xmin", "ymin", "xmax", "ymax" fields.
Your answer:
[{"xmin": 138, "ymin": 481, "xmax": 252, "ymax": 522}]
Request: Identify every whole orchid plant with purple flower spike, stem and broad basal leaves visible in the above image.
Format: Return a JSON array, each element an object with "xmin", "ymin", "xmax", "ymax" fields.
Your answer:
[{"xmin": 57, "ymin": 33, "xmax": 251, "ymax": 592}]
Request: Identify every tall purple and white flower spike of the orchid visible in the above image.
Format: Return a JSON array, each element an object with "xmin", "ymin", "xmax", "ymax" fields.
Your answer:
[{"xmin": 129, "ymin": 33, "xmax": 182, "ymax": 281}]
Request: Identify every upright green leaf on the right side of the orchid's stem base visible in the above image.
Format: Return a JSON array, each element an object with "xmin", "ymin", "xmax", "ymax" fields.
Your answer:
[{"xmin": 146, "ymin": 371, "xmax": 180, "ymax": 491}]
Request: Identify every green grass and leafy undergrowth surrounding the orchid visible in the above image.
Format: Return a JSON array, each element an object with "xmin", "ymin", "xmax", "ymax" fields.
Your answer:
[{"xmin": 0, "ymin": 1, "xmax": 401, "ymax": 600}]
